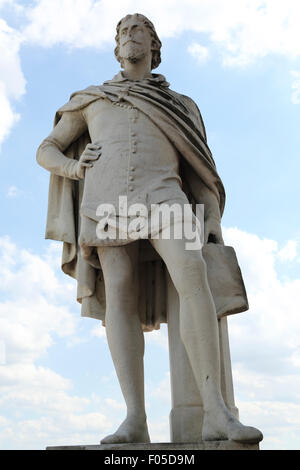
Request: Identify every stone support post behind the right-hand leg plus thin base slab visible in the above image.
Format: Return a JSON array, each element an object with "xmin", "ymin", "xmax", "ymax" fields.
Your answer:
[{"xmin": 46, "ymin": 279, "xmax": 259, "ymax": 454}]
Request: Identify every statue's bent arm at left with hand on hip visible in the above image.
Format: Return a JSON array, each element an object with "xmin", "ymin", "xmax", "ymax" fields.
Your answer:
[{"xmin": 36, "ymin": 111, "xmax": 100, "ymax": 180}]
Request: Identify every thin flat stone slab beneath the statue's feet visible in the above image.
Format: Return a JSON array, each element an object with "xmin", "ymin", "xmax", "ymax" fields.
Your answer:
[{"xmin": 46, "ymin": 441, "xmax": 259, "ymax": 452}]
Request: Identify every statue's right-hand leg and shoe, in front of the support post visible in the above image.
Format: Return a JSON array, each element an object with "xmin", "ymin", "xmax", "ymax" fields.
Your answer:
[{"xmin": 150, "ymin": 239, "xmax": 262, "ymax": 443}]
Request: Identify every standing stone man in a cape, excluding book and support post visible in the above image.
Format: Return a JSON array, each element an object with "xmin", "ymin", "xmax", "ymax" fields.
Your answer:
[{"xmin": 37, "ymin": 14, "xmax": 262, "ymax": 443}]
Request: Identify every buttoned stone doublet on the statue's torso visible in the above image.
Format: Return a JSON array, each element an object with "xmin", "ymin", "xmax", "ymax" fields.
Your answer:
[{"xmin": 79, "ymin": 90, "xmax": 188, "ymax": 250}]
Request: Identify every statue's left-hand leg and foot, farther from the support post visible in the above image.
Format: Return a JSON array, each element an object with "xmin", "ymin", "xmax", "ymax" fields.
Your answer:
[{"xmin": 98, "ymin": 243, "xmax": 150, "ymax": 444}]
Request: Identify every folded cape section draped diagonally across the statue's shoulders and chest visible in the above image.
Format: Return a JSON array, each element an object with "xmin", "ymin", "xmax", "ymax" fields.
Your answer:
[{"xmin": 55, "ymin": 80, "xmax": 225, "ymax": 214}]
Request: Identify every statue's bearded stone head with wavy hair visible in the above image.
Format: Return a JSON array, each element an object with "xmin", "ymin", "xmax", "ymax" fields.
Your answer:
[{"xmin": 115, "ymin": 13, "xmax": 161, "ymax": 70}]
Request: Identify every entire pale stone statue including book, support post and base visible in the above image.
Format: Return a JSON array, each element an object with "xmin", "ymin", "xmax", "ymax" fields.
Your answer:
[{"xmin": 37, "ymin": 14, "xmax": 262, "ymax": 450}]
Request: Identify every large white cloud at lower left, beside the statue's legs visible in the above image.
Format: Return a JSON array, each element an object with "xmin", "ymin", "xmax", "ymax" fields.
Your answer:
[{"xmin": 0, "ymin": 237, "xmax": 112, "ymax": 449}]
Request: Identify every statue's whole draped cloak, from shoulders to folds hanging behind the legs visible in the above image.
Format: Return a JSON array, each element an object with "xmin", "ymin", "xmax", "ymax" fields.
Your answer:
[{"xmin": 42, "ymin": 74, "xmax": 239, "ymax": 331}]
